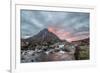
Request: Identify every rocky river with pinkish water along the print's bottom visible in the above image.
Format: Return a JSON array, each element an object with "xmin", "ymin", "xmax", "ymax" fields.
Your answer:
[{"xmin": 21, "ymin": 46, "xmax": 75, "ymax": 63}]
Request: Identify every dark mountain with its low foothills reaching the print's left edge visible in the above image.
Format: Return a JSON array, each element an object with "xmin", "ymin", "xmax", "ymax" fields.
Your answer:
[{"xmin": 21, "ymin": 28, "xmax": 68, "ymax": 48}]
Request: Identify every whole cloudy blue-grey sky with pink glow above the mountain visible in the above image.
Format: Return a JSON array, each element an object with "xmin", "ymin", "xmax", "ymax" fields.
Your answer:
[{"xmin": 20, "ymin": 9, "xmax": 90, "ymax": 41}]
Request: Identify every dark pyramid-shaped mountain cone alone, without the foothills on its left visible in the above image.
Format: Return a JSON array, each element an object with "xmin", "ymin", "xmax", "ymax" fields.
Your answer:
[{"xmin": 21, "ymin": 28, "xmax": 67, "ymax": 47}]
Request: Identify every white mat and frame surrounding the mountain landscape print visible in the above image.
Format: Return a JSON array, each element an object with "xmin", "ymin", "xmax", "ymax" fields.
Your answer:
[{"xmin": 11, "ymin": 4, "xmax": 95, "ymax": 73}]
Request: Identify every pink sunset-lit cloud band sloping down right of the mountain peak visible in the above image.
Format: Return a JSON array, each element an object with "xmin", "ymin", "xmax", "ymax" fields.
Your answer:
[{"xmin": 48, "ymin": 27, "xmax": 88, "ymax": 42}]
